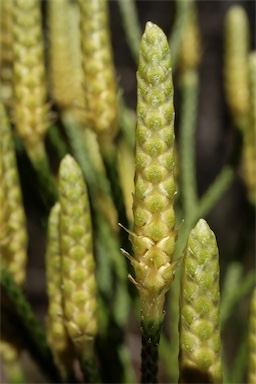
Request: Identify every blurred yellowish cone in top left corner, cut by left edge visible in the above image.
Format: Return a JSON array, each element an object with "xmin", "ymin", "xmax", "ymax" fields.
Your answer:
[{"xmin": 0, "ymin": 0, "xmax": 13, "ymax": 102}]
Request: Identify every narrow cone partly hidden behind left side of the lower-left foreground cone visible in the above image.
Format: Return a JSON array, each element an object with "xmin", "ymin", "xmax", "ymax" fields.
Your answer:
[{"xmin": 46, "ymin": 203, "xmax": 72, "ymax": 378}]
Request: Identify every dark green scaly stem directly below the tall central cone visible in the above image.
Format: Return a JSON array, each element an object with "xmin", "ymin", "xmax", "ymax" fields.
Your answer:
[{"xmin": 141, "ymin": 320, "xmax": 162, "ymax": 384}]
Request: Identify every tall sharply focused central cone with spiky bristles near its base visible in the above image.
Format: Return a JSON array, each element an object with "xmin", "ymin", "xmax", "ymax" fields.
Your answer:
[{"xmin": 125, "ymin": 22, "xmax": 177, "ymax": 324}]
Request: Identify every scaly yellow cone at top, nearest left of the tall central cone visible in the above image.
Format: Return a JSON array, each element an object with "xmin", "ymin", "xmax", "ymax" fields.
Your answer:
[{"xmin": 79, "ymin": 0, "xmax": 118, "ymax": 138}]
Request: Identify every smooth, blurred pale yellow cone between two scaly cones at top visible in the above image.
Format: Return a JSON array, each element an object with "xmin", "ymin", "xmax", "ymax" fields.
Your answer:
[{"xmin": 47, "ymin": 0, "xmax": 84, "ymax": 113}]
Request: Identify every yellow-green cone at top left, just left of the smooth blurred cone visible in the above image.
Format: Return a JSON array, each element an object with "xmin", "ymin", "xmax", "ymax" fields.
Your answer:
[{"xmin": 13, "ymin": 0, "xmax": 49, "ymax": 160}]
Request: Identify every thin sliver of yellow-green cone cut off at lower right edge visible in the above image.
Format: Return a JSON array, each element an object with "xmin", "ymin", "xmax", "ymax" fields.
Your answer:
[{"xmin": 248, "ymin": 288, "xmax": 256, "ymax": 384}]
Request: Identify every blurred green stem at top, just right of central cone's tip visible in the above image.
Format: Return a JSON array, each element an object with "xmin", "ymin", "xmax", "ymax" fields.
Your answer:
[{"xmin": 169, "ymin": 0, "xmax": 193, "ymax": 71}]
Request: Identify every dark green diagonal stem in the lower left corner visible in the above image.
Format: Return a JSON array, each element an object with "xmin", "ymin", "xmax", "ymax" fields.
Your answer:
[{"xmin": 0, "ymin": 265, "xmax": 61, "ymax": 383}]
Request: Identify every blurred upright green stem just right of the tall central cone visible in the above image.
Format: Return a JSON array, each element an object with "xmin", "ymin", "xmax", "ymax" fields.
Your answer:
[{"xmin": 180, "ymin": 71, "xmax": 198, "ymax": 221}]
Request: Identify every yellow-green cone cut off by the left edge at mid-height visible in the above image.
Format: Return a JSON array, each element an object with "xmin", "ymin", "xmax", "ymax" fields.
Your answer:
[{"xmin": 0, "ymin": 103, "xmax": 28, "ymax": 285}]
